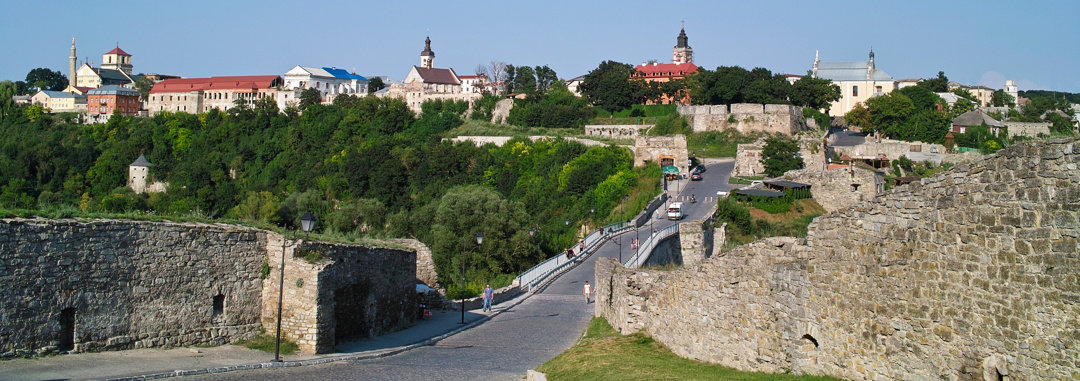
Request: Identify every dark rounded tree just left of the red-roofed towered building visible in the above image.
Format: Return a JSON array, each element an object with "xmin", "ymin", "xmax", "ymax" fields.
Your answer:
[{"xmin": 579, "ymin": 60, "xmax": 640, "ymax": 112}]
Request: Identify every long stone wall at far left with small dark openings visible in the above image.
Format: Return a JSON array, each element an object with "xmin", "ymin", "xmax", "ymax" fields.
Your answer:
[{"xmin": 0, "ymin": 219, "xmax": 267, "ymax": 354}]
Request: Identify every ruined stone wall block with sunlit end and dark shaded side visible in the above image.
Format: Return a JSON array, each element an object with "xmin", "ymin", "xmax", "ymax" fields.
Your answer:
[{"xmin": 261, "ymin": 241, "xmax": 419, "ymax": 353}]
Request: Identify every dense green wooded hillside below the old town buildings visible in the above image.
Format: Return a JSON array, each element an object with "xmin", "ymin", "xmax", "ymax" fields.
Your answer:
[{"xmin": 0, "ymin": 91, "xmax": 660, "ymax": 292}]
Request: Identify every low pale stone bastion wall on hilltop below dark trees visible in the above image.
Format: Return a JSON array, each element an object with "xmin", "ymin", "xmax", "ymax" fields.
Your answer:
[{"xmin": 676, "ymin": 104, "xmax": 807, "ymax": 135}]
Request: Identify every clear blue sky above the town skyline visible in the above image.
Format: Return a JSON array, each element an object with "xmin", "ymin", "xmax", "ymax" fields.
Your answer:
[{"xmin": 0, "ymin": 0, "xmax": 1080, "ymax": 93}]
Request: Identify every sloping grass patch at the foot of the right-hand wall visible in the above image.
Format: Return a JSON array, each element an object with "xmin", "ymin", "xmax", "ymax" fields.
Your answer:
[{"xmin": 537, "ymin": 317, "xmax": 835, "ymax": 380}]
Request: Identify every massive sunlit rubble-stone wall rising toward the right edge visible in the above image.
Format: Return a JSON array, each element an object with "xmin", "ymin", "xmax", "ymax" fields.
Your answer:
[{"xmin": 595, "ymin": 139, "xmax": 1080, "ymax": 380}]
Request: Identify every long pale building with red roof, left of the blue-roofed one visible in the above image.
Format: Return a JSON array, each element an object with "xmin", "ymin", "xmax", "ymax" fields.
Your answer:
[{"xmin": 147, "ymin": 76, "xmax": 297, "ymax": 115}]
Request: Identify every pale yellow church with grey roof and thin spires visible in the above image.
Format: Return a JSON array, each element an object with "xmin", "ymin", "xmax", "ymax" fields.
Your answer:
[{"xmin": 811, "ymin": 50, "xmax": 896, "ymax": 117}]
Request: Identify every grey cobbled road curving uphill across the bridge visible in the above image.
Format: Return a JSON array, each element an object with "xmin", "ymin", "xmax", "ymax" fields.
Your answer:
[{"xmin": 186, "ymin": 160, "xmax": 734, "ymax": 380}]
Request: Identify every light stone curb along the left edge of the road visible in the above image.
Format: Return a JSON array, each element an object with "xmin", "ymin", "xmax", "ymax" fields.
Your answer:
[{"xmin": 104, "ymin": 292, "xmax": 531, "ymax": 381}]
